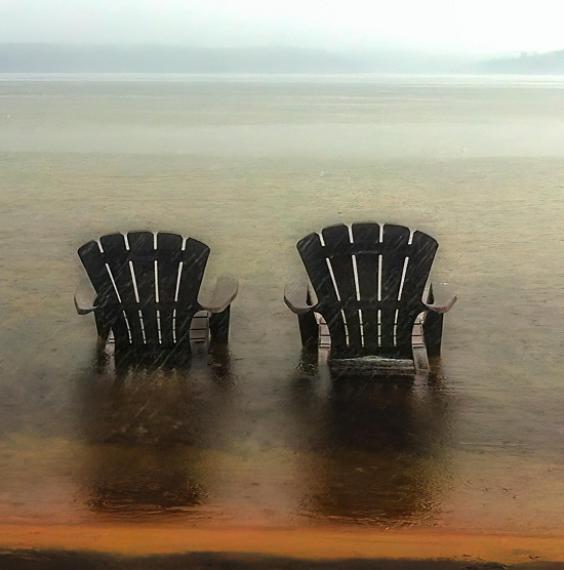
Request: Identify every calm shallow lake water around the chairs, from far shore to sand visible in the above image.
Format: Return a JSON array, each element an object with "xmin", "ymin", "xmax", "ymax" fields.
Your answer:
[{"xmin": 0, "ymin": 77, "xmax": 564, "ymax": 533}]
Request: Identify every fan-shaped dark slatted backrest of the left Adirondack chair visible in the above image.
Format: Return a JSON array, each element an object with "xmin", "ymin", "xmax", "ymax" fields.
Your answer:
[{"xmin": 78, "ymin": 232, "xmax": 209, "ymax": 347}]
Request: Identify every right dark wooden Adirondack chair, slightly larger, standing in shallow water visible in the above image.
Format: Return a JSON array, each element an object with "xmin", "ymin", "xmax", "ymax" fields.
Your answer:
[{"xmin": 284, "ymin": 223, "xmax": 456, "ymax": 374}]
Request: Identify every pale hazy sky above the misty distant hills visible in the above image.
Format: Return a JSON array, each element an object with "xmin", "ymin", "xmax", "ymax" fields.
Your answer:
[{"xmin": 0, "ymin": 0, "xmax": 564, "ymax": 54}]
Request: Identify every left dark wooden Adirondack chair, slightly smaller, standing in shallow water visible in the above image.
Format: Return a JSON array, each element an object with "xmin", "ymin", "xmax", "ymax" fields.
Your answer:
[{"xmin": 74, "ymin": 232, "xmax": 238, "ymax": 355}]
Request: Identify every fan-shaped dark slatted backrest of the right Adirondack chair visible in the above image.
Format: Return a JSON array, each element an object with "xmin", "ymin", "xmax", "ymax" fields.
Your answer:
[{"xmin": 298, "ymin": 223, "xmax": 438, "ymax": 358}]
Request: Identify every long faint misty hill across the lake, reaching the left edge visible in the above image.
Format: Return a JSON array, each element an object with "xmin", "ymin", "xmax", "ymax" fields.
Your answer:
[{"xmin": 0, "ymin": 44, "xmax": 463, "ymax": 73}]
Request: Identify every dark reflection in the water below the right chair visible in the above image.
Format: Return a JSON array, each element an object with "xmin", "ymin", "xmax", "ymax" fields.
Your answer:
[{"xmin": 288, "ymin": 351, "xmax": 456, "ymax": 527}]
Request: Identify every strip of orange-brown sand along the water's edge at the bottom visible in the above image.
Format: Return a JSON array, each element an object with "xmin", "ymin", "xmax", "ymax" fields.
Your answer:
[{"xmin": 0, "ymin": 524, "xmax": 564, "ymax": 564}]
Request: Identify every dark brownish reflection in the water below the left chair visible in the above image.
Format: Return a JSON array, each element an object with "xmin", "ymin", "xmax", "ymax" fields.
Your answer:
[{"xmin": 77, "ymin": 345, "xmax": 233, "ymax": 520}]
